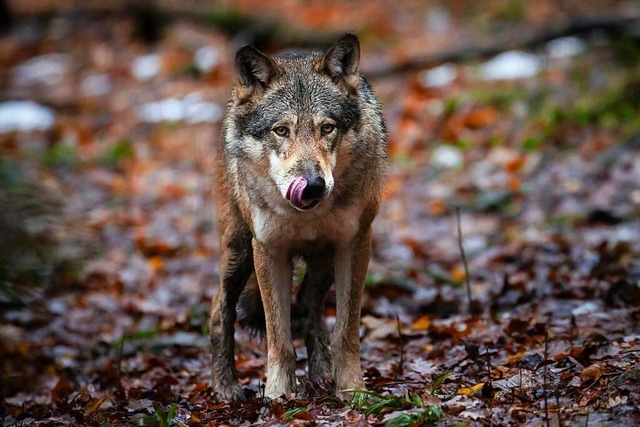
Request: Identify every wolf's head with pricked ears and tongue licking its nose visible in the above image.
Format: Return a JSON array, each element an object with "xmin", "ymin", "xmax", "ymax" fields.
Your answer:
[{"xmin": 231, "ymin": 34, "xmax": 361, "ymax": 211}]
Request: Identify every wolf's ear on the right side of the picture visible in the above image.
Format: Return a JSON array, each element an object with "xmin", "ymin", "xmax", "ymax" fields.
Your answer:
[{"xmin": 317, "ymin": 33, "xmax": 360, "ymax": 89}]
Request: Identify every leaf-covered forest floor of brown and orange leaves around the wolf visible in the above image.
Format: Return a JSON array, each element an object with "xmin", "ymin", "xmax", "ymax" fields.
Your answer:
[{"xmin": 0, "ymin": 0, "xmax": 640, "ymax": 427}]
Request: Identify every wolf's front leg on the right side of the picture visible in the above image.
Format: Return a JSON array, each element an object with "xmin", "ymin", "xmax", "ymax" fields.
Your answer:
[{"xmin": 331, "ymin": 229, "xmax": 371, "ymax": 395}]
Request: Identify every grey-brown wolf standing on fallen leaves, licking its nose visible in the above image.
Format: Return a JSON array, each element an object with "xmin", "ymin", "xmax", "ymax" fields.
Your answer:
[{"xmin": 209, "ymin": 33, "xmax": 388, "ymax": 400}]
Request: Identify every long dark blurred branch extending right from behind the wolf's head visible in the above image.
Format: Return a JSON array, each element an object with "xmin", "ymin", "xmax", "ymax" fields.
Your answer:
[{"xmin": 365, "ymin": 15, "xmax": 640, "ymax": 78}]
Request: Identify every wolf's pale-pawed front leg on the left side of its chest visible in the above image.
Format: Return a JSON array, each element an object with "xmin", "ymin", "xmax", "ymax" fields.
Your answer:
[{"xmin": 253, "ymin": 239, "xmax": 296, "ymax": 399}]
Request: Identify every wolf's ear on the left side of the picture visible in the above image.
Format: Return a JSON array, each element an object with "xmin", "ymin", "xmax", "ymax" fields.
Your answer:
[{"xmin": 235, "ymin": 46, "xmax": 278, "ymax": 102}]
